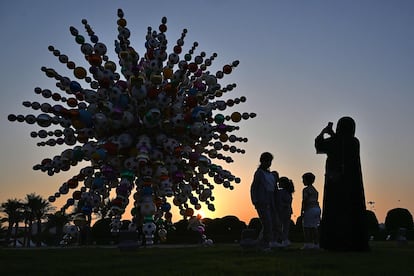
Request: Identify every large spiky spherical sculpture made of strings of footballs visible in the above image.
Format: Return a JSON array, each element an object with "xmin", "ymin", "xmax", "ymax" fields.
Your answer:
[{"xmin": 8, "ymin": 10, "xmax": 256, "ymax": 244}]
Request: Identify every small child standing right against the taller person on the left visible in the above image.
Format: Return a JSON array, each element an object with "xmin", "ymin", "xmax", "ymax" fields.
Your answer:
[{"xmin": 277, "ymin": 176, "xmax": 295, "ymax": 246}]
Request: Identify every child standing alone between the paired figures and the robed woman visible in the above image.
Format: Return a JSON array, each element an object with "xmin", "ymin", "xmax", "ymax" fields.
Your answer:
[{"xmin": 301, "ymin": 172, "xmax": 321, "ymax": 249}]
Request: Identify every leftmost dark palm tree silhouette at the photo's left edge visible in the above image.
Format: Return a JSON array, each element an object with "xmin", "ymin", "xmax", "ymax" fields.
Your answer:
[{"xmin": 0, "ymin": 199, "xmax": 23, "ymax": 246}]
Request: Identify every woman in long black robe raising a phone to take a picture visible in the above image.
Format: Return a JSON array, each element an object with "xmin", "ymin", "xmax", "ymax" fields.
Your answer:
[{"xmin": 315, "ymin": 117, "xmax": 369, "ymax": 251}]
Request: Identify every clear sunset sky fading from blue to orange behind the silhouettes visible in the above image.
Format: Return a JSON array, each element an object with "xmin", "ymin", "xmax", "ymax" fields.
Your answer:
[{"xmin": 0, "ymin": 0, "xmax": 414, "ymax": 223}]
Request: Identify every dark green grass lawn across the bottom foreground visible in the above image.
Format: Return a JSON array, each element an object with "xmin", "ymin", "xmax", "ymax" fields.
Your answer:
[{"xmin": 0, "ymin": 242, "xmax": 414, "ymax": 276}]
